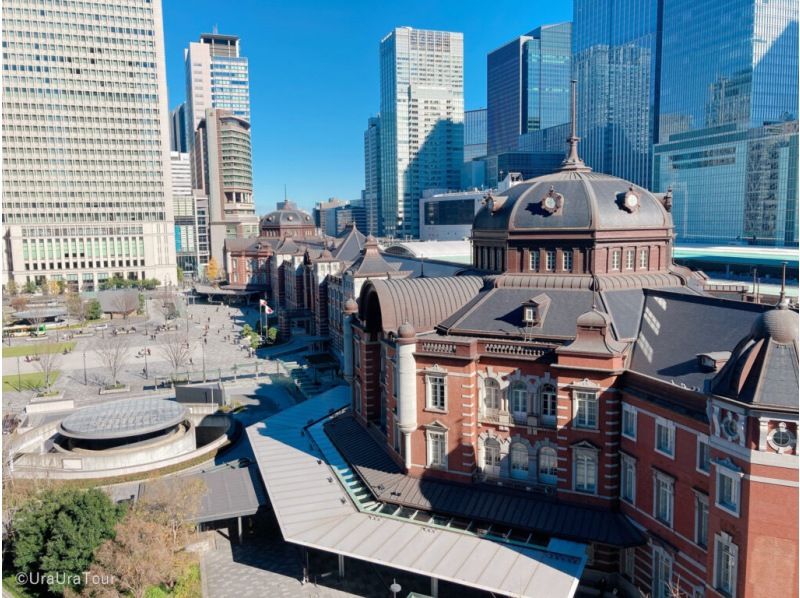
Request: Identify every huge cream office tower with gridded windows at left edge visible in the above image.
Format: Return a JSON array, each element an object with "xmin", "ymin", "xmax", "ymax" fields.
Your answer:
[{"xmin": 2, "ymin": 0, "xmax": 176, "ymax": 290}]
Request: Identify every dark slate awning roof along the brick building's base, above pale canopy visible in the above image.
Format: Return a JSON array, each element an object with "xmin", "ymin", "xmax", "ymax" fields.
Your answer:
[{"xmin": 325, "ymin": 414, "xmax": 645, "ymax": 546}]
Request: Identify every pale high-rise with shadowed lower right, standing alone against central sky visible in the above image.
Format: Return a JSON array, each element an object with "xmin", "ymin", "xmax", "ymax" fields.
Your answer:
[{"xmin": 380, "ymin": 27, "xmax": 464, "ymax": 237}]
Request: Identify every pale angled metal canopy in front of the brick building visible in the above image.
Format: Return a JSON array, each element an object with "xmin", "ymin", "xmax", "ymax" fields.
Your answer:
[{"xmin": 247, "ymin": 386, "xmax": 586, "ymax": 597}]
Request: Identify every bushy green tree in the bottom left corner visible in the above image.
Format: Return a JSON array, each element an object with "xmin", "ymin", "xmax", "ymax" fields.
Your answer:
[{"xmin": 11, "ymin": 488, "xmax": 124, "ymax": 593}]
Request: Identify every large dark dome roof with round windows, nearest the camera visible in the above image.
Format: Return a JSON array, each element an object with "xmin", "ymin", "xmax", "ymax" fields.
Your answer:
[{"xmin": 473, "ymin": 169, "xmax": 672, "ymax": 232}]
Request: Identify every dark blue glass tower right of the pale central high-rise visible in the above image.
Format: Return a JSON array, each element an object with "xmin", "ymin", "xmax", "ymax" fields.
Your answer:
[{"xmin": 486, "ymin": 23, "xmax": 572, "ymax": 155}]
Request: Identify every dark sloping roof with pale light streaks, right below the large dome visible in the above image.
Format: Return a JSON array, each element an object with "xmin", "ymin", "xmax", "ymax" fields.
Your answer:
[{"xmin": 629, "ymin": 290, "xmax": 766, "ymax": 391}]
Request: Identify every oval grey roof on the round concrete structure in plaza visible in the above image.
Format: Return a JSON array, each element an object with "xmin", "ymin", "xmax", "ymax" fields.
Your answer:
[{"xmin": 58, "ymin": 398, "xmax": 186, "ymax": 440}]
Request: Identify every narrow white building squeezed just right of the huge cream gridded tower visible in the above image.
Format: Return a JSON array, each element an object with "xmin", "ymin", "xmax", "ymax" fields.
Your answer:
[{"xmin": 170, "ymin": 152, "xmax": 208, "ymax": 276}]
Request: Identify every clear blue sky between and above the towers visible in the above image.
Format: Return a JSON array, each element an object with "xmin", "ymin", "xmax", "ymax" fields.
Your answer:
[{"xmin": 162, "ymin": 0, "xmax": 572, "ymax": 213}]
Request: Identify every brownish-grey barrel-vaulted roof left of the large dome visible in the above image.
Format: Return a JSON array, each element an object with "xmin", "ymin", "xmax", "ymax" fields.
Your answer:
[{"xmin": 359, "ymin": 276, "xmax": 483, "ymax": 333}]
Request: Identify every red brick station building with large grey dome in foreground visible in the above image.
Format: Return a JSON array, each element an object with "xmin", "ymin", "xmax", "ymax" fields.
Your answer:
[{"xmin": 344, "ymin": 145, "xmax": 798, "ymax": 598}]
